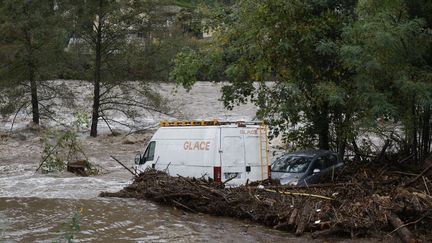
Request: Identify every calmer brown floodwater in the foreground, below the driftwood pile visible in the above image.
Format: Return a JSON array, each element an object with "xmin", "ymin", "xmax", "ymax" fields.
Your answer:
[{"xmin": 0, "ymin": 198, "xmax": 299, "ymax": 242}]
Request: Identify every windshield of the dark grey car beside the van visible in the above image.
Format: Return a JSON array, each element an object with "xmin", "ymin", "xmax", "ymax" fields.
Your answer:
[{"xmin": 272, "ymin": 155, "xmax": 312, "ymax": 173}]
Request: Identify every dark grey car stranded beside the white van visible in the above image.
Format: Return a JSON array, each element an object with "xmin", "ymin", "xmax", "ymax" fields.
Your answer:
[{"xmin": 271, "ymin": 150, "xmax": 343, "ymax": 186}]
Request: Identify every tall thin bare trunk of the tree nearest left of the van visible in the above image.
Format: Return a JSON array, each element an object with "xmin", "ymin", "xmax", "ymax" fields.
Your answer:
[{"xmin": 90, "ymin": 6, "xmax": 102, "ymax": 137}]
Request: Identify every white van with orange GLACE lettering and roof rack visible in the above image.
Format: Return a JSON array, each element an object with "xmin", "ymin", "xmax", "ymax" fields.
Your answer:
[{"xmin": 135, "ymin": 121, "xmax": 270, "ymax": 185}]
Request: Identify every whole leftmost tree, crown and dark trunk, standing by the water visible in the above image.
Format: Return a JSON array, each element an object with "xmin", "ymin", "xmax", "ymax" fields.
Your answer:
[{"xmin": 0, "ymin": 0, "xmax": 64, "ymax": 124}]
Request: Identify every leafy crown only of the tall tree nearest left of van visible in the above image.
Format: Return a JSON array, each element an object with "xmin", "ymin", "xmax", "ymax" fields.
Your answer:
[{"xmin": 63, "ymin": 0, "xmax": 189, "ymax": 83}]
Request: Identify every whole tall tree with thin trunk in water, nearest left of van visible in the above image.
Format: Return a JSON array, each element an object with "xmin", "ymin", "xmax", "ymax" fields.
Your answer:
[{"xmin": 63, "ymin": 0, "xmax": 199, "ymax": 136}]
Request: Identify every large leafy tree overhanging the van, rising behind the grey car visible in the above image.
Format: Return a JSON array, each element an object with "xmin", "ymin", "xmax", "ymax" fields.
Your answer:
[{"xmin": 172, "ymin": 0, "xmax": 360, "ymax": 154}]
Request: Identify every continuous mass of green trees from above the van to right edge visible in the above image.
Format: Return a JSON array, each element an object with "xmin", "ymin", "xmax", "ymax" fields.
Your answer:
[{"xmin": 171, "ymin": 0, "xmax": 432, "ymax": 160}]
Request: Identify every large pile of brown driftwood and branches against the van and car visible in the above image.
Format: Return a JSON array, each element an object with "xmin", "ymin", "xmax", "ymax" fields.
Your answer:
[{"xmin": 101, "ymin": 161, "xmax": 432, "ymax": 242}]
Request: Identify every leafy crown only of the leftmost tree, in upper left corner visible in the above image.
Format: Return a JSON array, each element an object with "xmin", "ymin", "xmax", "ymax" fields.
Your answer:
[{"xmin": 0, "ymin": 0, "xmax": 65, "ymax": 82}]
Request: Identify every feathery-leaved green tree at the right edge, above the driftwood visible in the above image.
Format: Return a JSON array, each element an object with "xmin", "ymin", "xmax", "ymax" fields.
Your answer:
[{"xmin": 341, "ymin": 0, "xmax": 432, "ymax": 161}]
